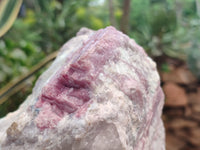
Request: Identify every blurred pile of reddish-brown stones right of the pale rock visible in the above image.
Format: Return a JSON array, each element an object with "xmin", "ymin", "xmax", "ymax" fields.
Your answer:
[{"xmin": 156, "ymin": 58, "xmax": 200, "ymax": 150}]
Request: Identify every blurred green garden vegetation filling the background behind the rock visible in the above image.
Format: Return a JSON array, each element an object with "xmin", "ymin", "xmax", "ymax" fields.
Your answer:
[{"xmin": 0, "ymin": 0, "xmax": 200, "ymax": 117}]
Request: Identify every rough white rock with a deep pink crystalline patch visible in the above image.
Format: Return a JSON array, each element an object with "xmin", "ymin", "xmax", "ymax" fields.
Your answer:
[{"xmin": 0, "ymin": 27, "xmax": 165, "ymax": 150}]
